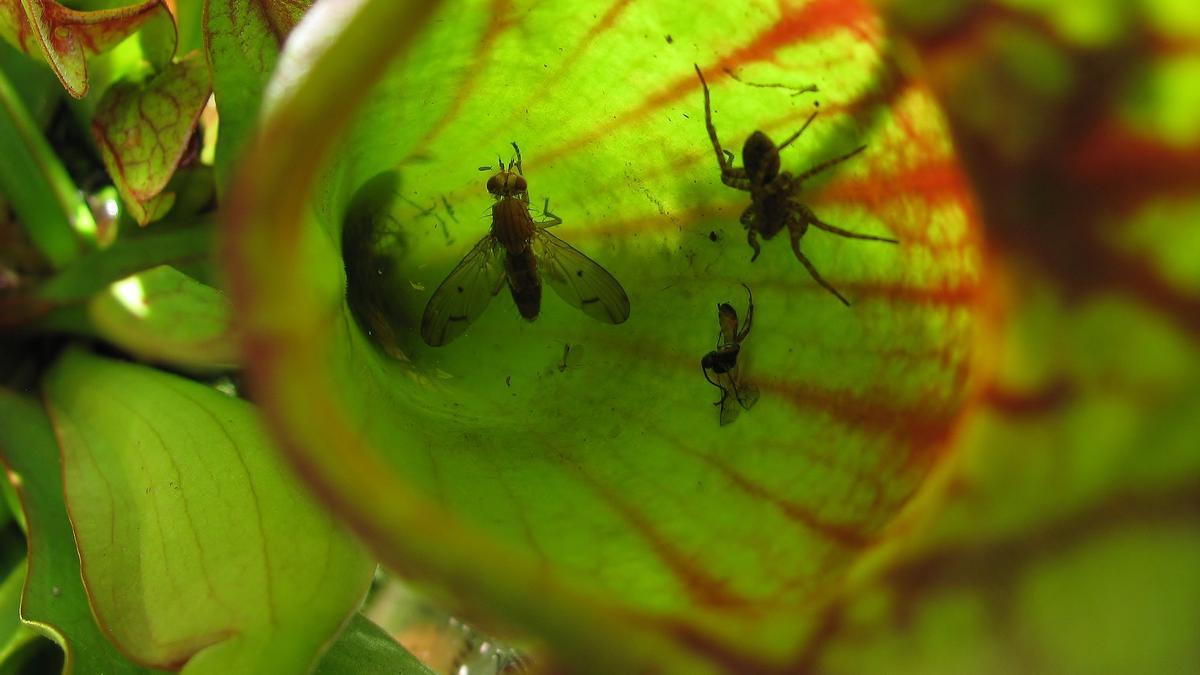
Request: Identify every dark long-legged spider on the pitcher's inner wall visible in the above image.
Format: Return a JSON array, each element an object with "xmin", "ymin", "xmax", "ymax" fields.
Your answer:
[{"xmin": 696, "ymin": 66, "xmax": 898, "ymax": 306}]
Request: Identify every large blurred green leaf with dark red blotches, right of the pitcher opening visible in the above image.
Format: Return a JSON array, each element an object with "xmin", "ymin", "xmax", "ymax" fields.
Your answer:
[{"xmin": 777, "ymin": 0, "xmax": 1200, "ymax": 674}]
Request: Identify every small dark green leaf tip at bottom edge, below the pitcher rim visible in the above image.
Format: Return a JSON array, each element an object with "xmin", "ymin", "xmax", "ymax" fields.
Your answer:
[{"xmin": 314, "ymin": 614, "xmax": 433, "ymax": 675}]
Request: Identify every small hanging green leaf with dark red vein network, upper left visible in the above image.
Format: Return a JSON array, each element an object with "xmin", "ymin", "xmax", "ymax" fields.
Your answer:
[{"xmin": 91, "ymin": 52, "xmax": 212, "ymax": 225}]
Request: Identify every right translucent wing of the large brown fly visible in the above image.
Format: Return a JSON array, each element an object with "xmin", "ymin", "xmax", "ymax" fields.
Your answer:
[{"xmin": 533, "ymin": 228, "xmax": 629, "ymax": 323}]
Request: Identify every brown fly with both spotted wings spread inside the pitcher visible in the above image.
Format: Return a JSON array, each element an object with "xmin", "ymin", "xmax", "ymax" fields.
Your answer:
[{"xmin": 421, "ymin": 143, "xmax": 629, "ymax": 347}]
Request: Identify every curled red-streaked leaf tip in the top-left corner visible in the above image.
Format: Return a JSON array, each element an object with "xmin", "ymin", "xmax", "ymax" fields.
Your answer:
[{"xmin": 0, "ymin": 0, "xmax": 174, "ymax": 98}]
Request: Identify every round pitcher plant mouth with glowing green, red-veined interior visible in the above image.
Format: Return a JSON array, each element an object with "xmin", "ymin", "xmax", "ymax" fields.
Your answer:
[{"xmin": 226, "ymin": 0, "xmax": 984, "ymax": 667}]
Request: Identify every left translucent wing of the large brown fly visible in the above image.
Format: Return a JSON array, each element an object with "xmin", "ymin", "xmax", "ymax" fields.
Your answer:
[{"xmin": 421, "ymin": 234, "xmax": 504, "ymax": 347}]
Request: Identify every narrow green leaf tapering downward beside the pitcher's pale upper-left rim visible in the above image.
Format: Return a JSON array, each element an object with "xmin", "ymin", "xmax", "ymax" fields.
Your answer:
[{"xmin": 204, "ymin": 0, "xmax": 312, "ymax": 187}]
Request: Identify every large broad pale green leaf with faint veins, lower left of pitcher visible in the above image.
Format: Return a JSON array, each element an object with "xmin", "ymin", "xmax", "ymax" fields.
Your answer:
[{"xmin": 44, "ymin": 351, "xmax": 373, "ymax": 674}]
